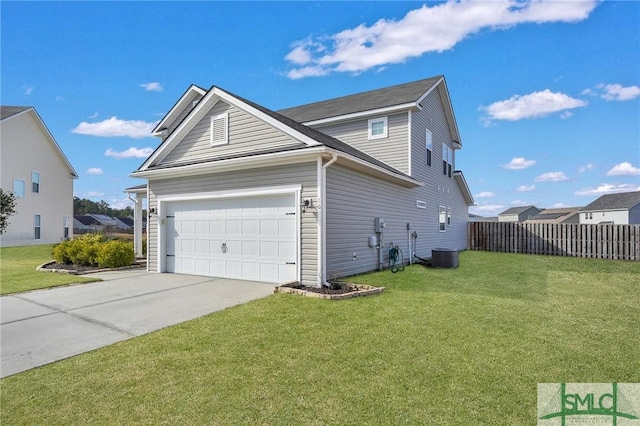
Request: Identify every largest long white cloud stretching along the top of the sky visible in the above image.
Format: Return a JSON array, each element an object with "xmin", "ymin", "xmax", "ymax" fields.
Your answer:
[{"xmin": 285, "ymin": 0, "xmax": 597, "ymax": 79}]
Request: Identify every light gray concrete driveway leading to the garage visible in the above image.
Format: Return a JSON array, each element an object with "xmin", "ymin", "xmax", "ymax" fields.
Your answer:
[{"xmin": 0, "ymin": 270, "xmax": 274, "ymax": 377}]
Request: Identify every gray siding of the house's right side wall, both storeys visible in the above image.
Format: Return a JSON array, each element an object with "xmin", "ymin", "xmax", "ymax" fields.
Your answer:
[{"xmin": 326, "ymin": 91, "xmax": 468, "ymax": 277}]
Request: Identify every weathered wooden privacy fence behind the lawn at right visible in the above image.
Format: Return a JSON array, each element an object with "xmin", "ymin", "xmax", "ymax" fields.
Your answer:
[{"xmin": 467, "ymin": 222, "xmax": 640, "ymax": 260}]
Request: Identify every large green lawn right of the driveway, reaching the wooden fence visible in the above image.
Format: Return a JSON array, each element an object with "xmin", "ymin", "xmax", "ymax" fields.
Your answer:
[{"xmin": 0, "ymin": 252, "xmax": 640, "ymax": 425}]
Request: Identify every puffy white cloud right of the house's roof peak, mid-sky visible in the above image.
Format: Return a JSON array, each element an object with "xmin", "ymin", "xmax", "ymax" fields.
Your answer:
[{"xmin": 480, "ymin": 89, "xmax": 587, "ymax": 124}]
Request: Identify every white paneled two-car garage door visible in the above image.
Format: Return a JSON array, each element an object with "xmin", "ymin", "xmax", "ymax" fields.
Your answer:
[{"xmin": 166, "ymin": 194, "xmax": 297, "ymax": 283}]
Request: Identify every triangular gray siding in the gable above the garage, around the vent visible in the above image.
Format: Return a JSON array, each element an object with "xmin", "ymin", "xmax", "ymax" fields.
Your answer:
[{"xmin": 161, "ymin": 101, "xmax": 300, "ymax": 165}]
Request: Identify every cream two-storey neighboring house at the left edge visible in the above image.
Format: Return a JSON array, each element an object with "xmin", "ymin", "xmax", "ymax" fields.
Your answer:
[{"xmin": 0, "ymin": 106, "xmax": 78, "ymax": 247}]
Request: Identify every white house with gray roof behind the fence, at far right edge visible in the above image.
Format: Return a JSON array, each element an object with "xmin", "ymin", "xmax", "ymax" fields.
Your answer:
[{"xmin": 580, "ymin": 191, "xmax": 640, "ymax": 225}]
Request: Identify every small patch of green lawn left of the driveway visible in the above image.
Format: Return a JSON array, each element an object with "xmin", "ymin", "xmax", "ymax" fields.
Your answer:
[{"xmin": 0, "ymin": 245, "xmax": 100, "ymax": 295}]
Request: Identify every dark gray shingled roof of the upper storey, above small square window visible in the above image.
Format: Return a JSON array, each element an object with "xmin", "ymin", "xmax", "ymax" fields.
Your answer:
[{"xmin": 278, "ymin": 75, "xmax": 442, "ymax": 123}]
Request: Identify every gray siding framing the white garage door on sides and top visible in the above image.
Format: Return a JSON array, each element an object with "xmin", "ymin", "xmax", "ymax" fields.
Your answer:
[{"xmin": 148, "ymin": 162, "xmax": 318, "ymax": 285}]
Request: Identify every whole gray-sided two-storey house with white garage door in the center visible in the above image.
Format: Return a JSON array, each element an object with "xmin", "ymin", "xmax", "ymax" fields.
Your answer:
[{"xmin": 131, "ymin": 76, "xmax": 473, "ymax": 286}]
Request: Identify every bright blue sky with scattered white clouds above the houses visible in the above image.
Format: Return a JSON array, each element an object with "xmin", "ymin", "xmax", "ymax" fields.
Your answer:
[{"xmin": 0, "ymin": 0, "xmax": 640, "ymax": 216}]
